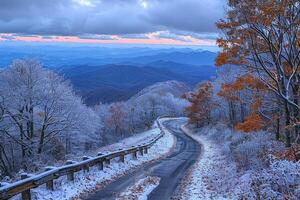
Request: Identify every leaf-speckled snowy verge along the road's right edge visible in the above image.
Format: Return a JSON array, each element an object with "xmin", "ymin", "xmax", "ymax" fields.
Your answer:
[{"xmin": 180, "ymin": 127, "xmax": 237, "ymax": 200}]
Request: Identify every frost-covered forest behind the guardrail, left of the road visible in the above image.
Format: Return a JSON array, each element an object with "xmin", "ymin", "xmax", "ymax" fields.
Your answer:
[{"xmin": 0, "ymin": 59, "xmax": 187, "ymax": 178}]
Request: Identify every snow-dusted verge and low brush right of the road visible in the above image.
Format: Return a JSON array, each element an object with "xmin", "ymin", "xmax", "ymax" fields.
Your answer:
[{"xmin": 181, "ymin": 125, "xmax": 300, "ymax": 200}]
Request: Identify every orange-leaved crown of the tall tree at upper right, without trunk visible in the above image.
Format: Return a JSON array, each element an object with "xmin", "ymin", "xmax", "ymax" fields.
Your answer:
[{"xmin": 215, "ymin": 0, "xmax": 300, "ymax": 82}]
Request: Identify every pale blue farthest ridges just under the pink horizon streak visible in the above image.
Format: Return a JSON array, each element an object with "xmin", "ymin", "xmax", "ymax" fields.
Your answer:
[{"xmin": 0, "ymin": 43, "xmax": 216, "ymax": 68}]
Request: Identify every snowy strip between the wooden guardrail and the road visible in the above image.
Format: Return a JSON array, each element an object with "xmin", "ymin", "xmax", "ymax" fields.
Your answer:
[{"xmin": 10, "ymin": 119, "xmax": 175, "ymax": 200}]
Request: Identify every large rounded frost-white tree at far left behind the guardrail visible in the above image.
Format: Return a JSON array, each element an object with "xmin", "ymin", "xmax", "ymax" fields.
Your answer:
[{"xmin": 0, "ymin": 60, "xmax": 100, "ymax": 177}]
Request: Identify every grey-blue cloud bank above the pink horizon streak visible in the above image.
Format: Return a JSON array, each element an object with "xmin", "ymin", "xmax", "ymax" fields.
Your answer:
[{"xmin": 0, "ymin": 0, "xmax": 225, "ymax": 37}]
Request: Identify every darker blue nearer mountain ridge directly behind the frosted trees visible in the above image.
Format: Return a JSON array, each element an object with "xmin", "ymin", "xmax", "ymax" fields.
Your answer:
[{"xmin": 61, "ymin": 61, "xmax": 215, "ymax": 105}]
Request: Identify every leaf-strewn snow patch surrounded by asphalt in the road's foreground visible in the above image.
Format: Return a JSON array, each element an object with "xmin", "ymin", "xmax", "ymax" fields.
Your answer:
[{"xmin": 116, "ymin": 176, "xmax": 160, "ymax": 200}]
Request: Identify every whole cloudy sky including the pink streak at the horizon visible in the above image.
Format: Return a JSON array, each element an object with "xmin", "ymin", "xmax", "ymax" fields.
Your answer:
[{"xmin": 0, "ymin": 0, "xmax": 225, "ymax": 45}]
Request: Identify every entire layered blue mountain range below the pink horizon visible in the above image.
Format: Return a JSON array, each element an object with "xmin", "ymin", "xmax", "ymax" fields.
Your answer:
[{"xmin": 0, "ymin": 43, "xmax": 216, "ymax": 105}]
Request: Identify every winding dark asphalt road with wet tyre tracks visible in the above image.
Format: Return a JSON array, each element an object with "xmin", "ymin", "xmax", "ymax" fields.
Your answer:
[{"xmin": 86, "ymin": 119, "xmax": 201, "ymax": 200}]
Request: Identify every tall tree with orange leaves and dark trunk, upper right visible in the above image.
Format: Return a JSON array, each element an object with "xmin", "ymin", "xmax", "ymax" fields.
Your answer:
[{"xmin": 216, "ymin": 0, "xmax": 300, "ymax": 146}]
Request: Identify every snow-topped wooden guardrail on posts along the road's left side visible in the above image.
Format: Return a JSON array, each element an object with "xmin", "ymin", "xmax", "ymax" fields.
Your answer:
[{"xmin": 0, "ymin": 118, "xmax": 164, "ymax": 200}]
